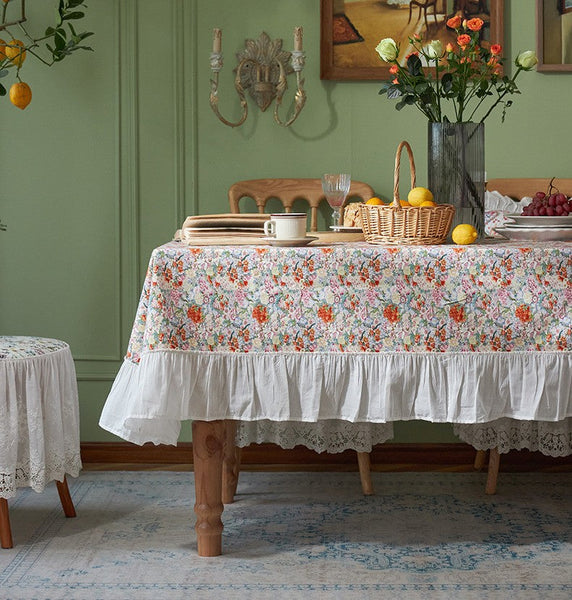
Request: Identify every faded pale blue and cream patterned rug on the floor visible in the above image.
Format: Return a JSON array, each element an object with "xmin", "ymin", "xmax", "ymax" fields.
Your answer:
[{"xmin": 0, "ymin": 472, "xmax": 572, "ymax": 600}]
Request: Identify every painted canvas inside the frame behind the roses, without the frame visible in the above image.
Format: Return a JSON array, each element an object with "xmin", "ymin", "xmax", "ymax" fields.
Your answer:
[{"xmin": 333, "ymin": 0, "xmax": 491, "ymax": 68}]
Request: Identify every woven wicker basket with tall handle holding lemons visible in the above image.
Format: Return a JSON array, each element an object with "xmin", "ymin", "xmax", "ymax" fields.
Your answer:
[{"xmin": 360, "ymin": 141, "xmax": 455, "ymax": 245}]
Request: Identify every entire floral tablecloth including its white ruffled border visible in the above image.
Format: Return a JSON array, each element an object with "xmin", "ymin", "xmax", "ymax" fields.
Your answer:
[{"xmin": 101, "ymin": 241, "xmax": 572, "ymax": 450}]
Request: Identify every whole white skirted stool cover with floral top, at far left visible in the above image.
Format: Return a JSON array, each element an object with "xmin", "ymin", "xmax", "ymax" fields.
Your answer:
[{"xmin": 0, "ymin": 336, "xmax": 82, "ymax": 498}]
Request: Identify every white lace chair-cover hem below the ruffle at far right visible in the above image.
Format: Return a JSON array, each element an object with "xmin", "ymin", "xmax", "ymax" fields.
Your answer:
[{"xmin": 454, "ymin": 418, "xmax": 572, "ymax": 457}]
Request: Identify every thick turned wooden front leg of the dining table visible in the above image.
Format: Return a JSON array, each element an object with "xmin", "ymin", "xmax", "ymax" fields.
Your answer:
[{"xmin": 193, "ymin": 421, "xmax": 225, "ymax": 556}]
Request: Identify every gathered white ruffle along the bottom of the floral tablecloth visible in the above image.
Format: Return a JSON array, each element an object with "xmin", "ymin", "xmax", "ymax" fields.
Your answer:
[{"xmin": 99, "ymin": 350, "xmax": 572, "ymax": 444}]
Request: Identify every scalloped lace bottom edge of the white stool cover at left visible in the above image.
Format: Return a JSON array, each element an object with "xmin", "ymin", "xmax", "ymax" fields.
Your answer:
[{"xmin": 0, "ymin": 452, "xmax": 82, "ymax": 498}]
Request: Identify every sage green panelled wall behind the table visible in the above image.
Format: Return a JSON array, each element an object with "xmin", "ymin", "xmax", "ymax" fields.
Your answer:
[{"xmin": 0, "ymin": 0, "xmax": 572, "ymax": 441}]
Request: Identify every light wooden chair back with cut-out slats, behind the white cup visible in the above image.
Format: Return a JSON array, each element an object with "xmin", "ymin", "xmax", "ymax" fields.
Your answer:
[{"xmin": 228, "ymin": 179, "xmax": 374, "ymax": 231}]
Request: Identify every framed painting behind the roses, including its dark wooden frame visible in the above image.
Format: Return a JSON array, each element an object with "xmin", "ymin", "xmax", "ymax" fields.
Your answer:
[{"xmin": 320, "ymin": 0, "xmax": 504, "ymax": 81}]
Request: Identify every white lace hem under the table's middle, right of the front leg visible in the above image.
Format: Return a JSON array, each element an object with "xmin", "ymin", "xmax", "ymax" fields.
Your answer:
[{"xmin": 236, "ymin": 420, "xmax": 393, "ymax": 454}]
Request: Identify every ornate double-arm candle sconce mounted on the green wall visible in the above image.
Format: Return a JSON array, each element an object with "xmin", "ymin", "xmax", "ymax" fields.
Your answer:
[{"xmin": 209, "ymin": 27, "xmax": 306, "ymax": 127}]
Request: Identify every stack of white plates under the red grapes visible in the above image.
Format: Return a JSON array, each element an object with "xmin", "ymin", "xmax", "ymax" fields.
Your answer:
[{"xmin": 495, "ymin": 213, "xmax": 572, "ymax": 242}]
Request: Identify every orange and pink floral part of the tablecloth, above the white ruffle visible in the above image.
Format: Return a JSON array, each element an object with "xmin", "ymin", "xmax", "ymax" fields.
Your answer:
[{"xmin": 127, "ymin": 241, "xmax": 572, "ymax": 363}]
